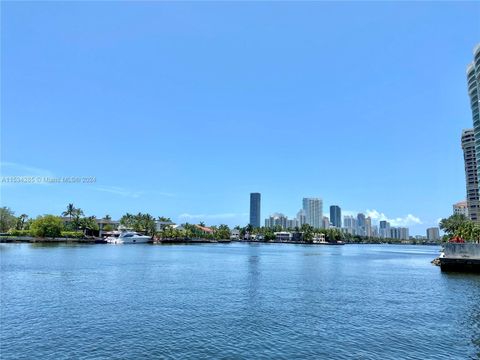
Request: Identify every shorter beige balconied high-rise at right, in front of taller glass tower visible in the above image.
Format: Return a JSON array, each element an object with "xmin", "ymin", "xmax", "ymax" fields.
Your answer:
[{"xmin": 462, "ymin": 129, "xmax": 480, "ymax": 221}]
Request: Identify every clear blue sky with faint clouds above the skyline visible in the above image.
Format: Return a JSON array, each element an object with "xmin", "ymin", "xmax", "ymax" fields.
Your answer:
[{"xmin": 1, "ymin": 2, "xmax": 480, "ymax": 234}]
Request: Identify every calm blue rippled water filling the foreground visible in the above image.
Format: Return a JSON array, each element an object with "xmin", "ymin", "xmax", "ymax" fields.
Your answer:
[{"xmin": 0, "ymin": 244, "xmax": 480, "ymax": 359}]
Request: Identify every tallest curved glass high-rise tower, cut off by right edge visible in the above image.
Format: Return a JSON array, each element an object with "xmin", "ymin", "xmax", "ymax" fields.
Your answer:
[{"xmin": 462, "ymin": 43, "xmax": 480, "ymax": 194}]
